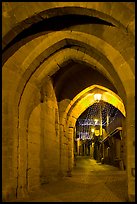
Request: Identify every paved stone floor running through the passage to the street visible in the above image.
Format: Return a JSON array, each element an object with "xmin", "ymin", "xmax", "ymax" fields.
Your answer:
[{"xmin": 13, "ymin": 157, "xmax": 127, "ymax": 202}]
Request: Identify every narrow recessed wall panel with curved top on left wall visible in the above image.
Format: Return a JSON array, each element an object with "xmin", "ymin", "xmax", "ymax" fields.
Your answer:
[{"xmin": 26, "ymin": 105, "xmax": 42, "ymax": 192}]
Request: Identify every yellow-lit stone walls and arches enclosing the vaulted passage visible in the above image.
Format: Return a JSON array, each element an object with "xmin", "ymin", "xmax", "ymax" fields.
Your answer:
[{"xmin": 2, "ymin": 2, "xmax": 135, "ymax": 201}]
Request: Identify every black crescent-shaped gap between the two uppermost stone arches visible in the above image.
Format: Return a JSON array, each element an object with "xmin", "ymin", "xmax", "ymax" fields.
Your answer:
[{"xmin": 2, "ymin": 14, "xmax": 114, "ymax": 64}]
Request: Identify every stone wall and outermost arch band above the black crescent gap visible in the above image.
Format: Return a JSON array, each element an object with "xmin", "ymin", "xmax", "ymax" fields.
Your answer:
[{"xmin": 2, "ymin": 2, "xmax": 134, "ymax": 51}]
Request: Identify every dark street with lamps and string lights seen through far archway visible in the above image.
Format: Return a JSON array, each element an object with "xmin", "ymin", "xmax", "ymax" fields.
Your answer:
[{"xmin": 74, "ymin": 101, "xmax": 126, "ymax": 170}]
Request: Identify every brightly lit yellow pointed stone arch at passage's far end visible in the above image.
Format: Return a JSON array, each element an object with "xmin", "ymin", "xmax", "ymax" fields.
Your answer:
[{"xmin": 60, "ymin": 85, "xmax": 126, "ymax": 172}]
